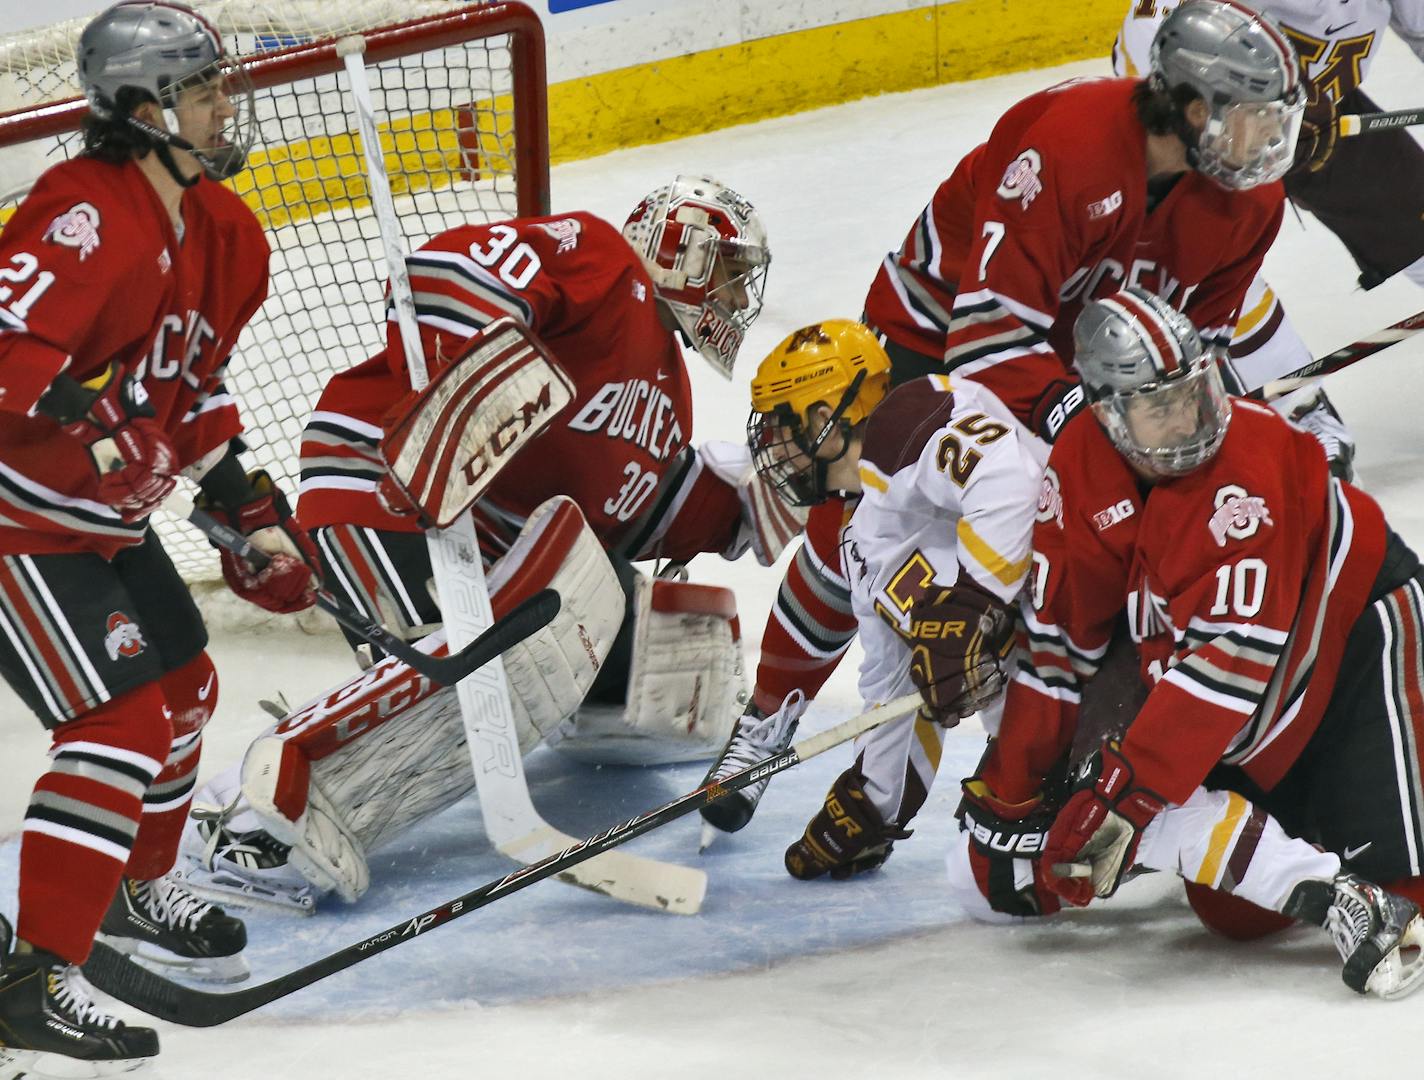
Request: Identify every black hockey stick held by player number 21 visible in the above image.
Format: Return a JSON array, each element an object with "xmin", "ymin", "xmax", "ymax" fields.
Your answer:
[{"xmin": 164, "ymin": 492, "xmax": 560, "ymax": 687}]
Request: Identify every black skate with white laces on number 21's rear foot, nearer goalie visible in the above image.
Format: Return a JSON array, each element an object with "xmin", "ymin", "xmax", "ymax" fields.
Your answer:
[{"xmin": 98, "ymin": 873, "xmax": 248, "ymax": 983}]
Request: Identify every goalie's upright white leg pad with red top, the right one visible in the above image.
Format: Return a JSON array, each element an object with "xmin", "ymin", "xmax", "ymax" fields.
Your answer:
[{"xmin": 550, "ymin": 576, "xmax": 750, "ymax": 765}]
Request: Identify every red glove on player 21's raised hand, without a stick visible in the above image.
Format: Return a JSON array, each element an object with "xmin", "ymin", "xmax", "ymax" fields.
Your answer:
[{"xmin": 38, "ymin": 360, "xmax": 178, "ymax": 521}]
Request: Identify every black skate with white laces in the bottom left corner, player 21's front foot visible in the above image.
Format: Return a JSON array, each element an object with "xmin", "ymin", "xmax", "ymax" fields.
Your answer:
[{"xmin": 0, "ymin": 916, "xmax": 158, "ymax": 1080}]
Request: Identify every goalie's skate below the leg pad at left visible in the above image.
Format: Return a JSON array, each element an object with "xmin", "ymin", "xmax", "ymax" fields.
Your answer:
[{"xmin": 172, "ymin": 806, "xmax": 322, "ymax": 915}]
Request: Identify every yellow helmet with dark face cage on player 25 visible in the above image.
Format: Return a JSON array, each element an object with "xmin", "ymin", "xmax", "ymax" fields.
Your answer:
[{"xmin": 746, "ymin": 319, "xmax": 890, "ymax": 506}]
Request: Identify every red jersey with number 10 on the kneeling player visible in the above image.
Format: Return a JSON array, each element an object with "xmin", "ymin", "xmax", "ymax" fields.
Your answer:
[{"xmin": 984, "ymin": 399, "xmax": 1387, "ymax": 802}]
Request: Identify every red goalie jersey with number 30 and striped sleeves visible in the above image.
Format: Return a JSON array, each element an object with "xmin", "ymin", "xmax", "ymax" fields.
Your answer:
[{"xmin": 300, "ymin": 212, "xmax": 740, "ymax": 557}]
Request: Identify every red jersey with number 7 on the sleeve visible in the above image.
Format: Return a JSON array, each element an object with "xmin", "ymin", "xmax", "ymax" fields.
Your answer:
[{"xmin": 866, "ymin": 78, "xmax": 1284, "ymax": 440}]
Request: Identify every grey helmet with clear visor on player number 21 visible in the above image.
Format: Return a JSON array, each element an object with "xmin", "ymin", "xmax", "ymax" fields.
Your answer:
[{"xmin": 74, "ymin": 0, "xmax": 255, "ymax": 180}]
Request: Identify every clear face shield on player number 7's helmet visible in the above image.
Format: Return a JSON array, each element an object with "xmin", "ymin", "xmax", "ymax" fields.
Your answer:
[{"xmin": 1196, "ymin": 85, "xmax": 1306, "ymax": 191}]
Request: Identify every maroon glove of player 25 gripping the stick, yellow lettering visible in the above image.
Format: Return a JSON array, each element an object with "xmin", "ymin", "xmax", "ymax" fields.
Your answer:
[{"xmin": 901, "ymin": 576, "xmax": 1014, "ymax": 728}]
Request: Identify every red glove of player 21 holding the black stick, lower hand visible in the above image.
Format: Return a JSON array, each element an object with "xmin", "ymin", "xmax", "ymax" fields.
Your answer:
[{"xmin": 197, "ymin": 469, "xmax": 322, "ymax": 614}]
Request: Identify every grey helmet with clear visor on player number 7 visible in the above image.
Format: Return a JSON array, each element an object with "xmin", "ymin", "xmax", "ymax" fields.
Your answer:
[{"xmin": 1152, "ymin": 0, "xmax": 1307, "ymax": 191}]
